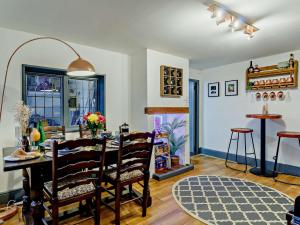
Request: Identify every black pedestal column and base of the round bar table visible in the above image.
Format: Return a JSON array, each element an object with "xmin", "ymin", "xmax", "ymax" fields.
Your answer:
[{"xmin": 250, "ymin": 119, "xmax": 273, "ymax": 177}]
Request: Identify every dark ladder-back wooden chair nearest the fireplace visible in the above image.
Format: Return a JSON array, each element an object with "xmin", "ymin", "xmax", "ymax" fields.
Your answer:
[{"xmin": 104, "ymin": 131, "xmax": 155, "ymax": 225}]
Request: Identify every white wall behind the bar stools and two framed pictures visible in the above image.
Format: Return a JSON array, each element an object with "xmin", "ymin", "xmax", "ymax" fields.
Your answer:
[{"xmin": 195, "ymin": 51, "xmax": 300, "ymax": 166}]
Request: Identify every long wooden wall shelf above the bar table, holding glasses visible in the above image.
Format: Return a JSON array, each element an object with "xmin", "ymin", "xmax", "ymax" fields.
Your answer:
[{"xmin": 246, "ymin": 60, "xmax": 298, "ymax": 91}]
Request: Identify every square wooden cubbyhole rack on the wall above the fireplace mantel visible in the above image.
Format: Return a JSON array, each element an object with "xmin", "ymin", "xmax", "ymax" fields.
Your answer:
[{"xmin": 160, "ymin": 66, "xmax": 183, "ymax": 98}]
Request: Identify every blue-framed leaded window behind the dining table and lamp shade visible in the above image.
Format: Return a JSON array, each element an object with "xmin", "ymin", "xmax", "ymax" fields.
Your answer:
[{"xmin": 23, "ymin": 65, "xmax": 104, "ymax": 127}]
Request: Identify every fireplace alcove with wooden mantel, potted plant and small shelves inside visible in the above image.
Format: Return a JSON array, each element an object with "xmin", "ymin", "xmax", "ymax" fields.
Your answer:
[{"xmin": 145, "ymin": 107, "xmax": 193, "ymax": 180}]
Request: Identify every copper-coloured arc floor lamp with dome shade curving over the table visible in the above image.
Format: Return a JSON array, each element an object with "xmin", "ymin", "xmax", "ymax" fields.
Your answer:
[{"xmin": 0, "ymin": 37, "xmax": 95, "ymax": 121}]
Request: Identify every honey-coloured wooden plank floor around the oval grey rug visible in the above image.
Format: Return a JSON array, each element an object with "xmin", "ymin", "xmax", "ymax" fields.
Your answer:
[{"xmin": 5, "ymin": 156, "xmax": 300, "ymax": 225}]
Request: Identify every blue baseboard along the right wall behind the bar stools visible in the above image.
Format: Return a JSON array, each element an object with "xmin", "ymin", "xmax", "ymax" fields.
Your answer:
[{"xmin": 199, "ymin": 148, "xmax": 300, "ymax": 177}]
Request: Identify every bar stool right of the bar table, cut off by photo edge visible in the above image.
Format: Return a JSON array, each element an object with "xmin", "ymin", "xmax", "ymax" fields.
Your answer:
[{"xmin": 273, "ymin": 131, "xmax": 300, "ymax": 186}]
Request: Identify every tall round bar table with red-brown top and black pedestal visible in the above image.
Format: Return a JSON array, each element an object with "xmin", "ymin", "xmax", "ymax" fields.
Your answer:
[{"xmin": 246, "ymin": 114, "xmax": 282, "ymax": 177}]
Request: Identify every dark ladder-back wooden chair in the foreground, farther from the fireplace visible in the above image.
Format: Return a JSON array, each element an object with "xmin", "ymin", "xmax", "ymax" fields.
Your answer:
[{"xmin": 44, "ymin": 139, "xmax": 106, "ymax": 225}]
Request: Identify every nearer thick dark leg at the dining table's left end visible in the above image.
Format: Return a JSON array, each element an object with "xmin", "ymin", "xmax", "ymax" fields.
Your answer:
[{"xmin": 30, "ymin": 168, "xmax": 45, "ymax": 225}]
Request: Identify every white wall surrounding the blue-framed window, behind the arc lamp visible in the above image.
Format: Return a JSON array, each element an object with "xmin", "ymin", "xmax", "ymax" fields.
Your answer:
[{"xmin": 0, "ymin": 28, "xmax": 130, "ymax": 192}]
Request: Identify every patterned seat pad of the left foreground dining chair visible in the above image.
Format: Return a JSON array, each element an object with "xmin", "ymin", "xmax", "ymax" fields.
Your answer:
[{"xmin": 44, "ymin": 181, "xmax": 95, "ymax": 200}]
